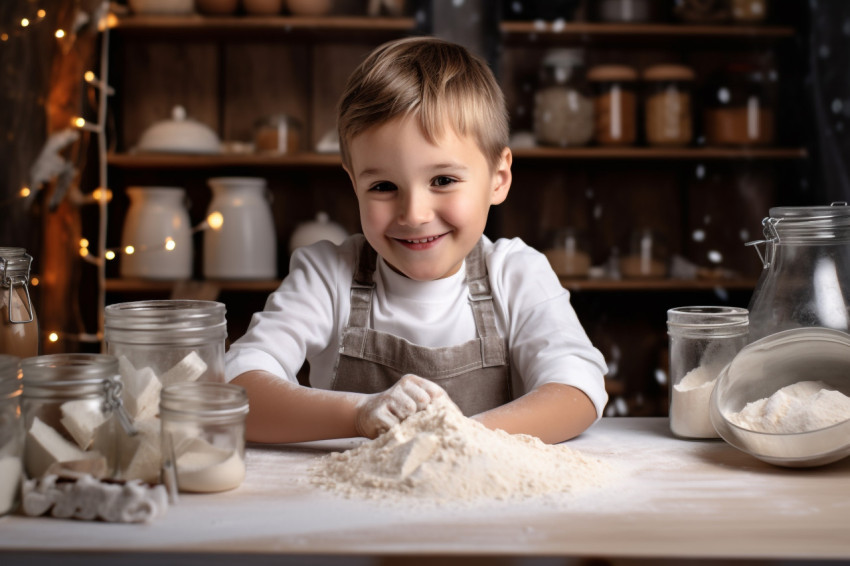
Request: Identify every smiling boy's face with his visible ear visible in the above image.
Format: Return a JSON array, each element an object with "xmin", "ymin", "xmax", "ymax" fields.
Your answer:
[{"xmin": 348, "ymin": 117, "xmax": 511, "ymax": 281}]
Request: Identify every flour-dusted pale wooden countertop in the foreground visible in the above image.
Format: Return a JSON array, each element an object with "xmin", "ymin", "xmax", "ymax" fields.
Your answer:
[{"xmin": 0, "ymin": 418, "xmax": 850, "ymax": 564}]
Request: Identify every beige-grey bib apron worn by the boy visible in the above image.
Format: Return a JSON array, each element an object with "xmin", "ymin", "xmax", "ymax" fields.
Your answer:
[{"xmin": 331, "ymin": 238, "xmax": 511, "ymax": 416}]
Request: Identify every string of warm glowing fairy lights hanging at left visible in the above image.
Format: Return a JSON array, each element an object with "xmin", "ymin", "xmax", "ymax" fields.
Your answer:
[{"xmin": 0, "ymin": 0, "xmax": 224, "ymax": 345}]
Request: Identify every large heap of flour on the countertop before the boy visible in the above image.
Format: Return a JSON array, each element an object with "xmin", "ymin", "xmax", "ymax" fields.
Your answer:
[{"xmin": 311, "ymin": 400, "xmax": 613, "ymax": 502}]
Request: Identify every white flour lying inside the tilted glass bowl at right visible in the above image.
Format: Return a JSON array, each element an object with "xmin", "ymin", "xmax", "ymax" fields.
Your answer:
[{"xmin": 726, "ymin": 381, "xmax": 850, "ymax": 434}]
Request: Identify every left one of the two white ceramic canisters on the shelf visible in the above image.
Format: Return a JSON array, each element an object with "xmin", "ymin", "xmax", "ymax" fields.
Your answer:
[{"xmin": 121, "ymin": 187, "xmax": 192, "ymax": 279}]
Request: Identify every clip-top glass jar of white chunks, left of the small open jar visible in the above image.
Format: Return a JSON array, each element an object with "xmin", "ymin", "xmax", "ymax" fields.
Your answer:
[{"xmin": 21, "ymin": 354, "xmax": 132, "ymax": 478}]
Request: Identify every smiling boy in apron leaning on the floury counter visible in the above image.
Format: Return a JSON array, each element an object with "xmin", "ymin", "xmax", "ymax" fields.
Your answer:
[{"xmin": 226, "ymin": 37, "xmax": 607, "ymax": 443}]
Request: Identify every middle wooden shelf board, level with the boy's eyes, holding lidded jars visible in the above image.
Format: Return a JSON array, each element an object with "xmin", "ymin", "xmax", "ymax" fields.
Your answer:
[{"xmin": 107, "ymin": 147, "xmax": 808, "ymax": 169}]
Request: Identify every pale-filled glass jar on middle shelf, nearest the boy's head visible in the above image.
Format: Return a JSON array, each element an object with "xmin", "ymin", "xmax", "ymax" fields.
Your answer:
[{"xmin": 534, "ymin": 49, "xmax": 594, "ymax": 147}]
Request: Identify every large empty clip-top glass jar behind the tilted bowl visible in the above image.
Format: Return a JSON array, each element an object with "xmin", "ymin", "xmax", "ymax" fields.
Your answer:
[{"xmin": 747, "ymin": 202, "xmax": 850, "ymax": 341}]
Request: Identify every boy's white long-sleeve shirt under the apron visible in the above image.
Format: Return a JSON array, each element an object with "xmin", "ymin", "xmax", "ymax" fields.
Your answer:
[{"xmin": 225, "ymin": 238, "xmax": 608, "ymax": 417}]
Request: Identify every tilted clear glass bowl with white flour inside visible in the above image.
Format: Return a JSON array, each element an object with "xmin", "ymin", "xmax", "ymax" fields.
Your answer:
[{"xmin": 710, "ymin": 328, "xmax": 850, "ymax": 467}]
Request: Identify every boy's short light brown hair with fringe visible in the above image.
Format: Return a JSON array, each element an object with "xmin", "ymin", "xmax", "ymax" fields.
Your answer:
[{"xmin": 338, "ymin": 37, "xmax": 509, "ymax": 171}]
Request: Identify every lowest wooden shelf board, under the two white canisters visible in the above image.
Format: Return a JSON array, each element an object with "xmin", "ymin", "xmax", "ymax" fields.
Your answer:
[{"xmin": 106, "ymin": 278, "xmax": 756, "ymax": 293}]
